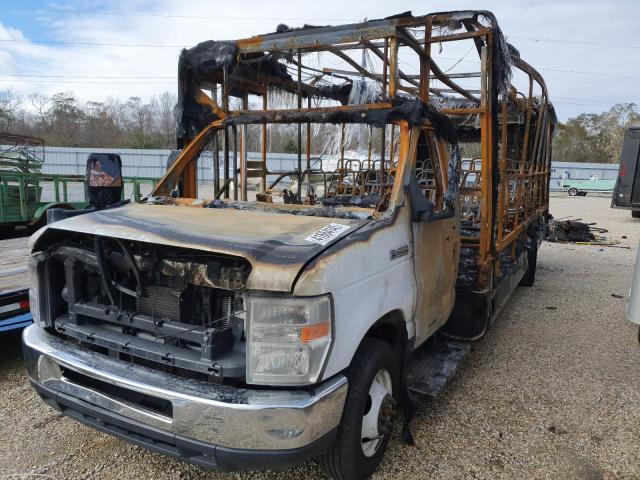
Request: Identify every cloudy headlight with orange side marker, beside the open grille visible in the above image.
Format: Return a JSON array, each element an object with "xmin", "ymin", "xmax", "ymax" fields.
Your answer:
[{"xmin": 247, "ymin": 296, "xmax": 332, "ymax": 385}]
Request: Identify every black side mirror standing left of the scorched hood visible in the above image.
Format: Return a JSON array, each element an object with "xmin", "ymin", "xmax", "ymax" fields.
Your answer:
[{"xmin": 84, "ymin": 153, "xmax": 122, "ymax": 210}]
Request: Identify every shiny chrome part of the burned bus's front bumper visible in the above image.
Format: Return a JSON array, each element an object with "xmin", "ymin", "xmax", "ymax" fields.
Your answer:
[{"xmin": 23, "ymin": 325, "xmax": 347, "ymax": 453}]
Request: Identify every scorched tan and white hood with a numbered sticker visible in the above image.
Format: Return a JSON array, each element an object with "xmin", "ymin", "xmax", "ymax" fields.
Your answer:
[{"xmin": 32, "ymin": 204, "xmax": 370, "ymax": 291}]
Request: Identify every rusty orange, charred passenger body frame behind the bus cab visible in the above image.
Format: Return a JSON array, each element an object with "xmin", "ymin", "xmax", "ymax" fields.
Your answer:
[{"xmin": 155, "ymin": 11, "xmax": 556, "ymax": 338}]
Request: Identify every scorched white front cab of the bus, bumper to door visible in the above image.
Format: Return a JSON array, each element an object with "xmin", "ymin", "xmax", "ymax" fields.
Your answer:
[{"xmin": 24, "ymin": 111, "xmax": 458, "ymax": 469}]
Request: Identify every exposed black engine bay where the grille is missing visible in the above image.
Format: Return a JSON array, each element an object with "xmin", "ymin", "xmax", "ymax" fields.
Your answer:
[{"xmin": 34, "ymin": 234, "xmax": 251, "ymax": 383}]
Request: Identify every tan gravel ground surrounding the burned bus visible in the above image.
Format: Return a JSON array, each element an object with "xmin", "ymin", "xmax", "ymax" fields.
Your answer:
[{"xmin": 0, "ymin": 195, "xmax": 640, "ymax": 479}]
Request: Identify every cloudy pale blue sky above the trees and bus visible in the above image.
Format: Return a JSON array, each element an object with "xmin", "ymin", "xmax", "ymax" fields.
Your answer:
[{"xmin": 0, "ymin": 0, "xmax": 640, "ymax": 121}]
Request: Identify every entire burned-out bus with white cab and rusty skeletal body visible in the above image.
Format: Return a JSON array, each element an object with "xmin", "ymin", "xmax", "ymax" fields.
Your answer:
[{"xmin": 23, "ymin": 11, "xmax": 555, "ymax": 479}]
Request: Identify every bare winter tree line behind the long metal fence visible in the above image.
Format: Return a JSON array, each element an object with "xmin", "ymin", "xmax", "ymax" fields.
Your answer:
[{"xmin": 0, "ymin": 90, "xmax": 640, "ymax": 163}]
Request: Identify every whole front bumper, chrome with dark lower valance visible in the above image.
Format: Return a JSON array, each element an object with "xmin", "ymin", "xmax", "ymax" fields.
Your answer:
[{"xmin": 23, "ymin": 325, "xmax": 347, "ymax": 470}]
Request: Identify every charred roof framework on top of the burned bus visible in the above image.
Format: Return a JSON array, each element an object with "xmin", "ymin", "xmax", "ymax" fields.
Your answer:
[{"xmin": 176, "ymin": 10, "xmax": 518, "ymax": 147}]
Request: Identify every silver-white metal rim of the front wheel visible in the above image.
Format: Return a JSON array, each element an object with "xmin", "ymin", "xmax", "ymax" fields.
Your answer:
[{"xmin": 360, "ymin": 369, "xmax": 393, "ymax": 457}]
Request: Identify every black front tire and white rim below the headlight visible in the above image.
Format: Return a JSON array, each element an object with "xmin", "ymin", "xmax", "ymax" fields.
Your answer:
[{"xmin": 320, "ymin": 338, "xmax": 400, "ymax": 480}]
